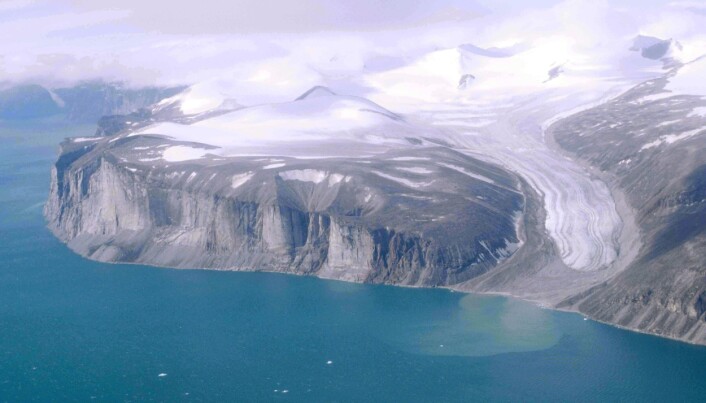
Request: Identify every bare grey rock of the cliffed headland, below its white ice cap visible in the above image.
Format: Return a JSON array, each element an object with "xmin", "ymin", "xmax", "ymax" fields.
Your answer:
[{"xmin": 45, "ymin": 136, "xmax": 524, "ymax": 286}]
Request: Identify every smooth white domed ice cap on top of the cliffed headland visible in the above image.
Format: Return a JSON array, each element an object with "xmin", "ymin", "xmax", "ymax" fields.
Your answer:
[{"xmin": 130, "ymin": 90, "xmax": 414, "ymax": 158}]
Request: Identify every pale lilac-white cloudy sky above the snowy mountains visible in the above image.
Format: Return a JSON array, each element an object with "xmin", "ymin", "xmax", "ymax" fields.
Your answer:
[{"xmin": 0, "ymin": 0, "xmax": 706, "ymax": 90}]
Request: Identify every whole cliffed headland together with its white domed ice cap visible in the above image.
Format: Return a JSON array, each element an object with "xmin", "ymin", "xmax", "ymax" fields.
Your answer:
[{"xmin": 46, "ymin": 87, "xmax": 525, "ymax": 286}]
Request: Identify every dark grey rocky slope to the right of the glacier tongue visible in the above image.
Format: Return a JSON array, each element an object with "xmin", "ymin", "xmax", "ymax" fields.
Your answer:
[{"xmin": 550, "ymin": 69, "xmax": 706, "ymax": 343}]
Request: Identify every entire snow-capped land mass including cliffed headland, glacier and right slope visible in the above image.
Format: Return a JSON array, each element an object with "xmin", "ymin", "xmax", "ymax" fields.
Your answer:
[{"xmin": 40, "ymin": 2, "xmax": 706, "ymax": 343}]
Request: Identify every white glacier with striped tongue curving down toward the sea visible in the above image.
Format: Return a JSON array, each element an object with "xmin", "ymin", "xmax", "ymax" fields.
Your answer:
[{"xmin": 368, "ymin": 38, "xmax": 676, "ymax": 271}]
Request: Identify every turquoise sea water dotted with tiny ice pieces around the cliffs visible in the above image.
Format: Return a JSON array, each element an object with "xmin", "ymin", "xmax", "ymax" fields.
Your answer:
[{"xmin": 0, "ymin": 119, "xmax": 706, "ymax": 402}]
